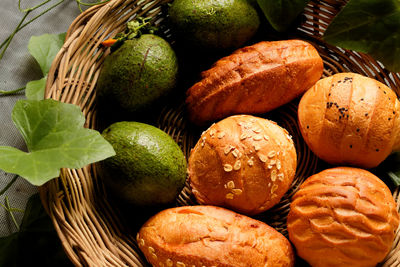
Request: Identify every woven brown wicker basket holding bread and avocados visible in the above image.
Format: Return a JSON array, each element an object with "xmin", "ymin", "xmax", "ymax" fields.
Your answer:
[{"xmin": 40, "ymin": 0, "xmax": 400, "ymax": 266}]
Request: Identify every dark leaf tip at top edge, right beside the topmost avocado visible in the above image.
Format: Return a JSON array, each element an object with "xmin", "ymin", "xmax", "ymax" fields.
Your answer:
[{"xmin": 257, "ymin": 0, "xmax": 309, "ymax": 32}]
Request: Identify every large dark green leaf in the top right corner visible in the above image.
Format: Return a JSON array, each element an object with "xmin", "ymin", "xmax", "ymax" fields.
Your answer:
[{"xmin": 323, "ymin": 0, "xmax": 400, "ymax": 72}]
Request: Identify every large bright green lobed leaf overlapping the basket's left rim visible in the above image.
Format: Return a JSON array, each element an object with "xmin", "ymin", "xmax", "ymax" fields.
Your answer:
[{"xmin": 0, "ymin": 99, "xmax": 115, "ymax": 185}]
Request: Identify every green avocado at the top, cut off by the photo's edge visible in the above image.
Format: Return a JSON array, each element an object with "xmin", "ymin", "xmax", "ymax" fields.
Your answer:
[{"xmin": 169, "ymin": 0, "xmax": 260, "ymax": 50}]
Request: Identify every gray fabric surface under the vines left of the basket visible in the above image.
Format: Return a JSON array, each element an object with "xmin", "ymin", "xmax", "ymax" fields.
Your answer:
[{"xmin": 0, "ymin": 0, "xmax": 80, "ymax": 239}]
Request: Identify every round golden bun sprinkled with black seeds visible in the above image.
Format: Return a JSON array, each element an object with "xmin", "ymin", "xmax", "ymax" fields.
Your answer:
[{"xmin": 298, "ymin": 73, "xmax": 400, "ymax": 168}]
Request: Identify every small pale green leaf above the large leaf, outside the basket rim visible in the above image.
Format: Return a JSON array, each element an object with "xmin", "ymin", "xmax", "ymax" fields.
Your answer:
[{"xmin": 28, "ymin": 33, "xmax": 66, "ymax": 76}]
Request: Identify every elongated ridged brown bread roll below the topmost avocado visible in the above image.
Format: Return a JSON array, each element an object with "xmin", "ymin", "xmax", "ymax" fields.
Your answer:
[{"xmin": 186, "ymin": 40, "xmax": 323, "ymax": 124}]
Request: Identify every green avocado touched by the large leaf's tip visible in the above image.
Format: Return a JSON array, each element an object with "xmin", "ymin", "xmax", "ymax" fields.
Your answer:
[{"xmin": 101, "ymin": 121, "xmax": 186, "ymax": 206}]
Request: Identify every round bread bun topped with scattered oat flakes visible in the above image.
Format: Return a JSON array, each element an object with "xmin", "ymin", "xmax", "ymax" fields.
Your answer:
[{"xmin": 188, "ymin": 115, "xmax": 297, "ymax": 215}]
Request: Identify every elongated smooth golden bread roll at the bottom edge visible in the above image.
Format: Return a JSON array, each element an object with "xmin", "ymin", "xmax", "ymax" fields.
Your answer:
[{"xmin": 137, "ymin": 206, "xmax": 294, "ymax": 267}]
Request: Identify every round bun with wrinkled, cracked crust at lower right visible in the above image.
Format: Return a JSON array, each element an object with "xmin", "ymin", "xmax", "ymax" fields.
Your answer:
[{"xmin": 287, "ymin": 167, "xmax": 399, "ymax": 267}]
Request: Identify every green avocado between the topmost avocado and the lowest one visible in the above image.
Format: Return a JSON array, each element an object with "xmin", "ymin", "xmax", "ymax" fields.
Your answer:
[{"xmin": 97, "ymin": 34, "xmax": 178, "ymax": 113}]
